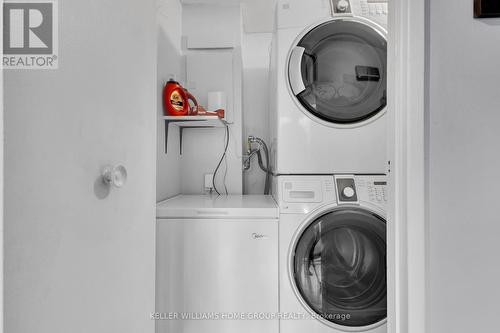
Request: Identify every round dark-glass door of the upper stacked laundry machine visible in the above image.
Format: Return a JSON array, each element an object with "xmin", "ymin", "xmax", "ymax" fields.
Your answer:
[{"xmin": 289, "ymin": 18, "xmax": 387, "ymax": 124}]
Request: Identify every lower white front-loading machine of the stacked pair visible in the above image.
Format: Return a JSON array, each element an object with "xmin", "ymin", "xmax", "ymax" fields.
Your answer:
[{"xmin": 274, "ymin": 175, "xmax": 387, "ymax": 333}]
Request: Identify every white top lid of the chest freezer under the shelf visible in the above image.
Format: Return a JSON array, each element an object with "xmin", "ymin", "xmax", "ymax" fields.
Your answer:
[{"xmin": 156, "ymin": 195, "xmax": 279, "ymax": 219}]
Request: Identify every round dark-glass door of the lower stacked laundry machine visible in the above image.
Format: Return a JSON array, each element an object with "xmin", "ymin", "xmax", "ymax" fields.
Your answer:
[{"xmin": 292, "ymin": 208, "xmax": 387, "ymax": 327}]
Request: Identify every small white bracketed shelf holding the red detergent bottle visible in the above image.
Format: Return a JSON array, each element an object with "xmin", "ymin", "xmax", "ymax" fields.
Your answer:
[{"xmin": 163, "ymin": 116, "xmax": 229, "ymax": 155}]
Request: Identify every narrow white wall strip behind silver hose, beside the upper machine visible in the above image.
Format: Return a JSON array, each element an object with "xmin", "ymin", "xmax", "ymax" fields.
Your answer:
[{"xmin": 241, "ymin": 33, "xmax": 272, "ymax": 194}]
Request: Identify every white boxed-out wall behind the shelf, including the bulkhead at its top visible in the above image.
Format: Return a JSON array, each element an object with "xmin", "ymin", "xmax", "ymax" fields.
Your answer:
[{"xmin": 180, "ymin": 5, "xmax": 243, "ymax": 194}]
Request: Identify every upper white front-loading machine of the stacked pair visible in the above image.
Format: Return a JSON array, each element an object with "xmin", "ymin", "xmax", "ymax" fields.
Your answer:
[{"xmin": 270, "ymin": 0, "xmax": 387, "ymax": 175}]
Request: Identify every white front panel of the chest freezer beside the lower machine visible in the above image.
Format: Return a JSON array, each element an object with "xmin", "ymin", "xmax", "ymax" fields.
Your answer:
[{"xmin": 157, "ymin": 220, "xmax": 278, "ymax": 333}]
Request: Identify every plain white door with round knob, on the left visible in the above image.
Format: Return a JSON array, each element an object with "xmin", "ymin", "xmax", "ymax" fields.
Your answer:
[{"xmin": 3, "ymin": 0, "xmax": 155, "ymax": 333}]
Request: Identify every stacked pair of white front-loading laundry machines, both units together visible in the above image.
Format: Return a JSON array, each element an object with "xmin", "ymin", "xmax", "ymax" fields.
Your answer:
[{"xmin": 271, "ymin": 0, "xmax": 387, "ymax": 333}]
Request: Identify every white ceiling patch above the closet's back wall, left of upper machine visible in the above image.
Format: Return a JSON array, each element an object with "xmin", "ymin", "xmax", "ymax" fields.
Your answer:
[{"xmin": 181, "ymin": 0, "xmax": 276, "ymax": 33}]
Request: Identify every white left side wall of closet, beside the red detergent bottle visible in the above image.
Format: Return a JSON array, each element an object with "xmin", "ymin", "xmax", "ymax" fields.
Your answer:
[{"xmin": 156, "ymin": 0, "xmax": 185, "ymax": 201}]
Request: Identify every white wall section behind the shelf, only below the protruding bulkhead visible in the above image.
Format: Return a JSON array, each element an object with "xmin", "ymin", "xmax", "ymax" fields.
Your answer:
[{"xmin": 182, "ymin": 49, "xmax": 243, "ymax": 194}]
